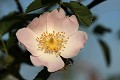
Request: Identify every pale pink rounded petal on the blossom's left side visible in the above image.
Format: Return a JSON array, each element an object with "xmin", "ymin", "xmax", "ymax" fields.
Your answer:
[{"xmin": 16, "ymin": 28, "xmax": 43, "ymax": 56}]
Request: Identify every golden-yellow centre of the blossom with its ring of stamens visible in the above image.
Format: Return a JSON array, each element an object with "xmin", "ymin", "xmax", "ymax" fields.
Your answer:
[{"xmin": 36, "ymin": 31, "xmax": 68, "ymax": 55}]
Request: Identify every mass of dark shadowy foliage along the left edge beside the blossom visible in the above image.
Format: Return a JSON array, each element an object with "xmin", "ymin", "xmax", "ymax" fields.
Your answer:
[{"xmin": 0, "ymin": 12, "xmax": 39, "ymax": 80}]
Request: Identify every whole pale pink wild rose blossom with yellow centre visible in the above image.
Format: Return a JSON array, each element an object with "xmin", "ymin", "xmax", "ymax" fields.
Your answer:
[{"xmin": 16, "ymin": 8, "xmax": 88, "ymax": 72}]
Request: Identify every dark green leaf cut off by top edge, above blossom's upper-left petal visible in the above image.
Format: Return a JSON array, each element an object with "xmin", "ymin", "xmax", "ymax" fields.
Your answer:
[{"xmin": 25, "ymin": 0, "xmax": 60, "ymax": 13}]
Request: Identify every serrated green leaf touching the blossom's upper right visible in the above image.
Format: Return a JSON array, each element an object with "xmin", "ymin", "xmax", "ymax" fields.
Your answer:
[{"xmin": 62, "ymin": 1, "xmax": 93, "ymax": 26}]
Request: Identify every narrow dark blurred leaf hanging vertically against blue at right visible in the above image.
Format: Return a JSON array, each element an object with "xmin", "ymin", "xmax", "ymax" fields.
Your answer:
[{"xmin": 99, "ymin": 40, "xmax": 111, "ymax": 66}]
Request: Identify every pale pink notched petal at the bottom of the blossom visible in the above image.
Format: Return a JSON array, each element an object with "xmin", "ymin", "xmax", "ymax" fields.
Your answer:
[{"xmin": 30, "ymin": 53, "xmax": 64, "ymax": 72}]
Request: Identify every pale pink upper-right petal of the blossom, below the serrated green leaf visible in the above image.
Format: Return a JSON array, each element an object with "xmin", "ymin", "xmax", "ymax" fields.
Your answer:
[{"xmin": 47, "ymin": 13, "xmax": 79, "ymax": 36}]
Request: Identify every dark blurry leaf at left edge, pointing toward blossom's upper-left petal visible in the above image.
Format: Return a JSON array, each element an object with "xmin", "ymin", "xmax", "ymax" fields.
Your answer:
[{"xmin": 0, "ymin": 12, "xmax": 39, "ymax": 38}]
